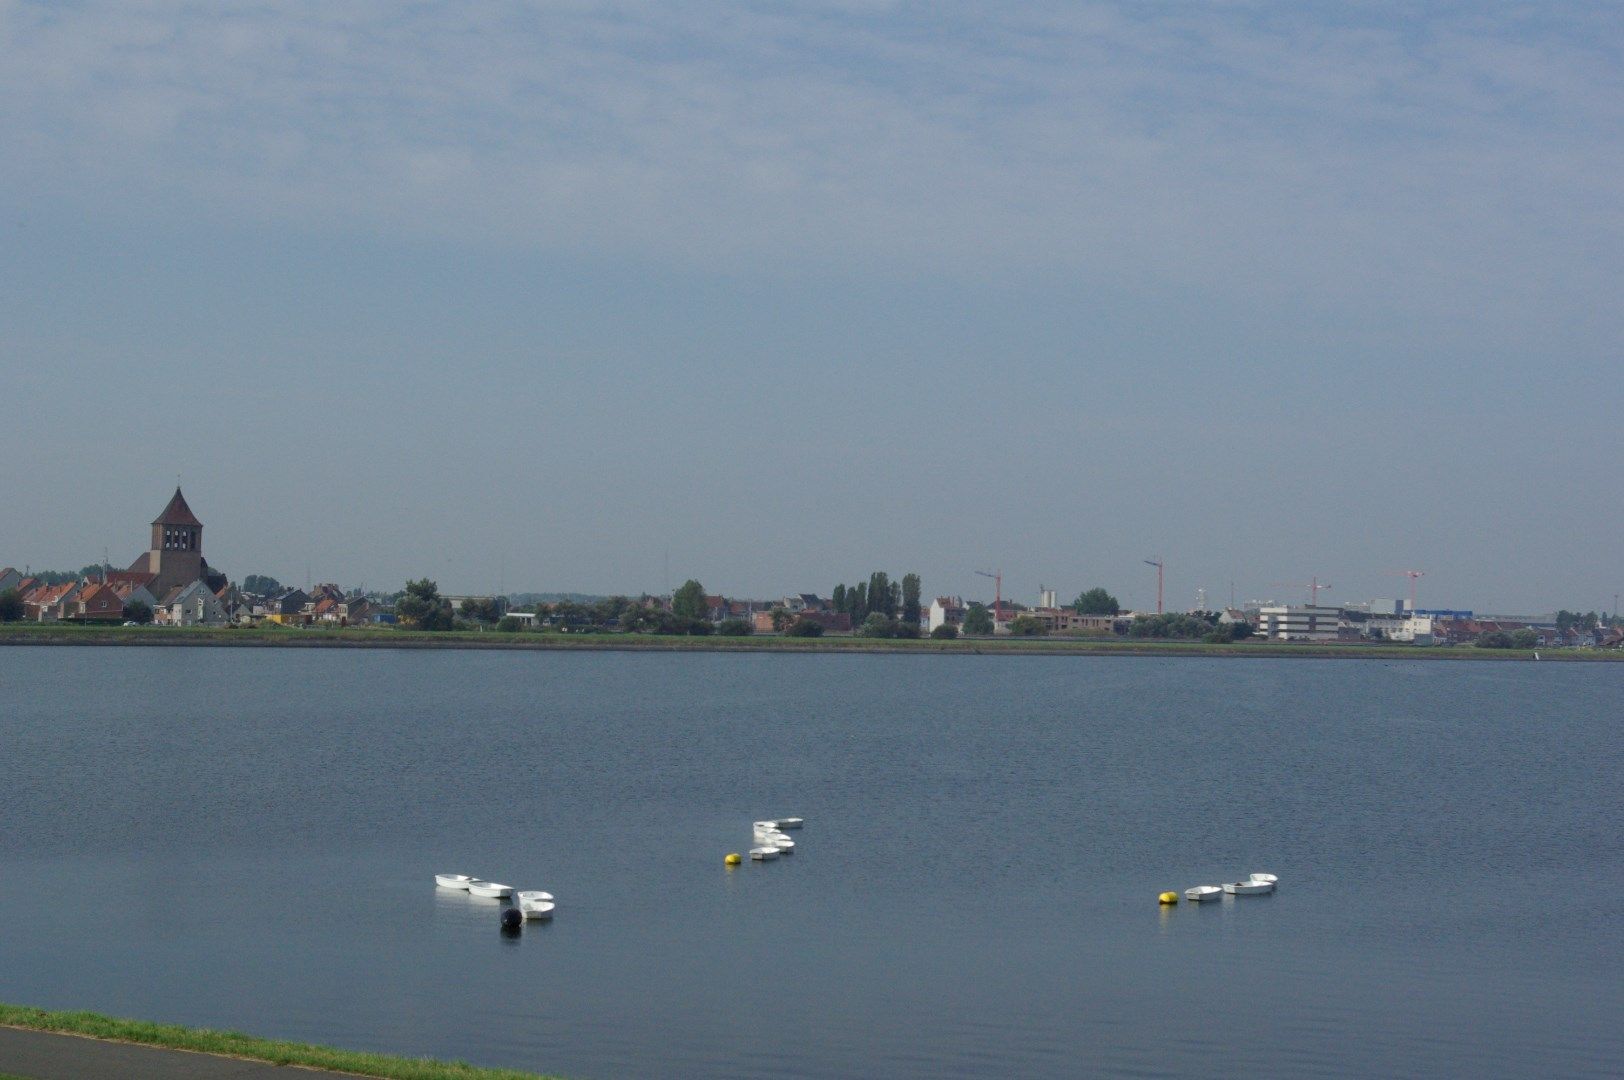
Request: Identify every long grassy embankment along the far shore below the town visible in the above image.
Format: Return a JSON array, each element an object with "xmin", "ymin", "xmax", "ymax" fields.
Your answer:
[{"xmin": 0, "ymin": 622, "xmax": 1624, "ymax": 661}]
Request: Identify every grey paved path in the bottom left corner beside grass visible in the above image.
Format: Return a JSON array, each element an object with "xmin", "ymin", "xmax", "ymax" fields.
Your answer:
[{"xmin": 0, "ymin": 1028, "xmax": 355, "ymax": 1080}]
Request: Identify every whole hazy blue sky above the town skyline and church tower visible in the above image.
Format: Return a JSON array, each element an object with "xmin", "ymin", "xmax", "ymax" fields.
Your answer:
[{"xmin": 0, "ymin": 0, "xmax": 1624, "ymax": 614}]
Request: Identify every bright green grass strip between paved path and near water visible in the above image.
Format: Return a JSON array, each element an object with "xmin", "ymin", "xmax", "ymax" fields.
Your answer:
[{"xmin": 0, "ymin": 1004, "xmax": 555, "ymax": 1080}]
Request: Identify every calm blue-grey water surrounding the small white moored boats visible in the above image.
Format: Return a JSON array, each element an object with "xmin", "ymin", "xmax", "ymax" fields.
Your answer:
[{"xmin": 0, "ymin": 648, "xmax": 1624, "ymax": 1080}]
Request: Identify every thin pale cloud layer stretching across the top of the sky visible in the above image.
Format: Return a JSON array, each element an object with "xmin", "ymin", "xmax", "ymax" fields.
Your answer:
[{"xmin": 0, "ymin": 2, "xmax": 1624, "ymax": 300}]
